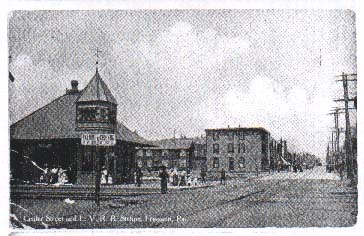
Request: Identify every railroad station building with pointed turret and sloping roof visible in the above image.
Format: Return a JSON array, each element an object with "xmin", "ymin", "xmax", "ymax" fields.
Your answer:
[{"xmin": 10, "ymin": 69, "xmax": 151, "ymax": 184}]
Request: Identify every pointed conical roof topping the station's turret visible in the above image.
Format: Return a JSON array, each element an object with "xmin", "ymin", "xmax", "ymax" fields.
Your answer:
[{"xmin": 77, "ymin": 69, "xmax": 117, "ymax": 104}]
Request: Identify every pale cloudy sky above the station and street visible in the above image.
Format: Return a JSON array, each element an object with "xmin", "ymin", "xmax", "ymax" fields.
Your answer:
[{"xmin": 8, "ymin": 10, "xmax": 356, "ymax": 157}]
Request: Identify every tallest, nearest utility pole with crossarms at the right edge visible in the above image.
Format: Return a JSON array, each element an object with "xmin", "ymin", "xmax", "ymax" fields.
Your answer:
[{"xmin": 335, "ymin": 72, "xmax": 356, "ymax": 180}]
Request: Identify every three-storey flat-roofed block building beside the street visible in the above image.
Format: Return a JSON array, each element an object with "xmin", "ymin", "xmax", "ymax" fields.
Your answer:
[{"xmin": 205, "ymin": 128, "xmax": 271, "ymax": 172}]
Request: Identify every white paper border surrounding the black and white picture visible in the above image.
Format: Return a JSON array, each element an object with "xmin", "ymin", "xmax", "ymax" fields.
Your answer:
[{"xmin": 0, "ymin": 0, "xmax": 364, "ymax": 236}]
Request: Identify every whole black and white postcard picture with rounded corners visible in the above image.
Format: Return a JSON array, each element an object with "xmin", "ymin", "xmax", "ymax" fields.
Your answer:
[{"xmin": 3, "ymin": 2, "xmax": 360, "ymax": 232}]
